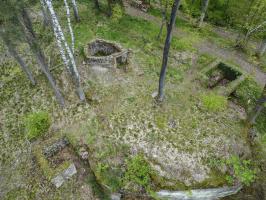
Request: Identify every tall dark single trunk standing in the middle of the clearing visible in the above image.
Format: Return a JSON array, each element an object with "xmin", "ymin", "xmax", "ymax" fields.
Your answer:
[{"xmin": 157, "ymin": 0, "xmax": 181, "ymax": 101}]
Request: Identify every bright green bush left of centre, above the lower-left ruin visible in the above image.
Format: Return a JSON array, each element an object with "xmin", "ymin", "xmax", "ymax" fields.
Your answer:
[{"xmin": 25, "ymin": 111, "xmax": 51, "ymax": 140}]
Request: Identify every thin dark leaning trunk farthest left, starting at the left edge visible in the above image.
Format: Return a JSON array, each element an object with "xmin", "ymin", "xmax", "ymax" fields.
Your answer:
[{"xmin": 2, "ymin": 33, "xmax": 36, "ymax": 85}]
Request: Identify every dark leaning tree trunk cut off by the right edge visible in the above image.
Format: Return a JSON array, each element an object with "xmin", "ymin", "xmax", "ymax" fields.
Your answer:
[{"xmin": 248, "ymin": 84, "xmax": 266, "ymax": 125}]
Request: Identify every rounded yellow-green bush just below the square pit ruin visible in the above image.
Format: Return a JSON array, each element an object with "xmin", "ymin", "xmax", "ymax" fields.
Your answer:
[{"xmin": 201, "ymin": 93, "xmax": 227, "ymax": 112}]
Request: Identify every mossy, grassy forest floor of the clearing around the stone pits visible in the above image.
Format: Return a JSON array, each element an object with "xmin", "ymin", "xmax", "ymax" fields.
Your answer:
[{"xmin": 0, "ymin": 2, "xmax": 266, "ymax": 200}]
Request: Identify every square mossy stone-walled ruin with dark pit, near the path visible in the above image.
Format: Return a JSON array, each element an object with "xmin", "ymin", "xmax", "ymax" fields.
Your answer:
[{"xmin": 200, "ymin": 60, "xmax": 246, "ymax": 96}]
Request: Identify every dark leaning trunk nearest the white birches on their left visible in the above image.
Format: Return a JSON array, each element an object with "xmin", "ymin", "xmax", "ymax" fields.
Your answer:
[{"xmin": 20, "ymin": 9, "xmax": 65, "ymax": 106}]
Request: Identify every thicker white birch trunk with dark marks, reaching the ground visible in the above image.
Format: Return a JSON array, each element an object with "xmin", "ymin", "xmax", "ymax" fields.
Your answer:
[{"xmin": 45, "ymin": 0, "xmax": 85, "ymax": 101}]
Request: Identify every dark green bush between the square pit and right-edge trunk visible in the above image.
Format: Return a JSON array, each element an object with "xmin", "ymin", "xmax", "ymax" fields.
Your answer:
[{"xmin": 236, "ymin": 77, "xmax": 262, "ymax": 110}]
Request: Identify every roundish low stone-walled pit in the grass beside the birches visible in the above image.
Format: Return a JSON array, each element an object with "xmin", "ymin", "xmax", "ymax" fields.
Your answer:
[{"xmin": 84, "ymin": 39, "xmax": 129, "ymax": 68}]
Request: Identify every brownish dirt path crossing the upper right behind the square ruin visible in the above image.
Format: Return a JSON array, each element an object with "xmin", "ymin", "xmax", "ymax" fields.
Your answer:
[{"xmin": 125, "ymin": 3, "xmax": 266, "ymax": 86}]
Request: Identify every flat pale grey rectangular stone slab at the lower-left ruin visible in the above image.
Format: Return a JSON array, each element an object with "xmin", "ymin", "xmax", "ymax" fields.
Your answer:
[{"xmin": 51, "ymin": 163, "xmax": 77, "ymax": 188}]
